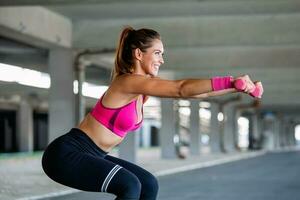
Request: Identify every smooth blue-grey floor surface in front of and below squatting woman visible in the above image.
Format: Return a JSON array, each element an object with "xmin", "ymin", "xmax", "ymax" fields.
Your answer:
[{"xmin": 47, "ymin": 151, "xmax": 300, "ymax": 200}]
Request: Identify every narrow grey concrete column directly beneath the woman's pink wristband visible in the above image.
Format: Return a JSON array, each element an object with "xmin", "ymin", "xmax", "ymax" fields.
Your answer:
[{"xmin": 209, "ymin": 103, "xmax": 221, "ymax": 153}]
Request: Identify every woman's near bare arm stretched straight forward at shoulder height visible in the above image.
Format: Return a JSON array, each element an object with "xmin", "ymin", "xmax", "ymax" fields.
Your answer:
[{"xmin": 113, "ymin": 74, "xmax": 254, "ymax": 98}]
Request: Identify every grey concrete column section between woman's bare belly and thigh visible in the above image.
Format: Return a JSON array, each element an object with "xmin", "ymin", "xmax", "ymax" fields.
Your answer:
[{"xmin": 119, "ymin": 131, "xmax": 140, "ymax": 163}]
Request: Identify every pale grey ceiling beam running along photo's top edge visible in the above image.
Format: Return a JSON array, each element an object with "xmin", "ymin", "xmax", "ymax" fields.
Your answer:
[{"xmin": 45, "ymin": 0, "xmax": 300, "ymax": 20}]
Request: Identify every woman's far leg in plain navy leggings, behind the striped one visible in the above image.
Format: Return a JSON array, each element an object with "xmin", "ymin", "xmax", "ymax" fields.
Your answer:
[{"xmin": 105, "ymin": 155, "xmax": 158, "ymax": 200}]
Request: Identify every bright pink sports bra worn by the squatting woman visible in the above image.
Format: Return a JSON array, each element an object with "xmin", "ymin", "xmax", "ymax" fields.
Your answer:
[{"xmin": 91, "ymin": 92, "xmax": 145, "ymax": 137}]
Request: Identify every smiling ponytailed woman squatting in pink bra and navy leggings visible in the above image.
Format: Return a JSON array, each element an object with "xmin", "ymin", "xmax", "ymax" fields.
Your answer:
[{"xmin": 42, "ymin": 27, "xmax": 262, "ymax": 200}]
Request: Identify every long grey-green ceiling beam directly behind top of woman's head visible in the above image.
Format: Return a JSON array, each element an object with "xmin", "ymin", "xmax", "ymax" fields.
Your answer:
[{"xmin": 73, "ymin": 13, "xmax": 300, "ymax": 49}]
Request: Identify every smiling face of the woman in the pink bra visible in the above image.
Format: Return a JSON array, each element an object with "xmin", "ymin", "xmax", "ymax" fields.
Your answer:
[{"xmin": 140, "ymin": 39, "xmax": 164, "ymax": 77}]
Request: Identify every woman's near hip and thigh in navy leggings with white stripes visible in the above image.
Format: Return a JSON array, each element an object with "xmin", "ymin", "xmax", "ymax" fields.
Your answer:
[{"xmin": 42, "ymin": 131, "xmax": 141, "ymax": 200}]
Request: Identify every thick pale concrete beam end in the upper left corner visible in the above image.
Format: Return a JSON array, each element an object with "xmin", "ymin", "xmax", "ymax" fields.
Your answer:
[{"xmin": 0, "ymin": 7, "xmax": 72, "ymax": 48}]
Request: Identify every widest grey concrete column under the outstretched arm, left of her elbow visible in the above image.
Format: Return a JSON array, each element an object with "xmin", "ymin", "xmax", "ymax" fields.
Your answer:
[{"xmin": 159, "ymin": 98, "xmax": 177, "ymax": 158}]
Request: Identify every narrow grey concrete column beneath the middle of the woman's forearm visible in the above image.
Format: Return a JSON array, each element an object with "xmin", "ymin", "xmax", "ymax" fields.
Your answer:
[{"xmin": 190, "ymin": 100, "xmax": 201, "ymax": 155}]
